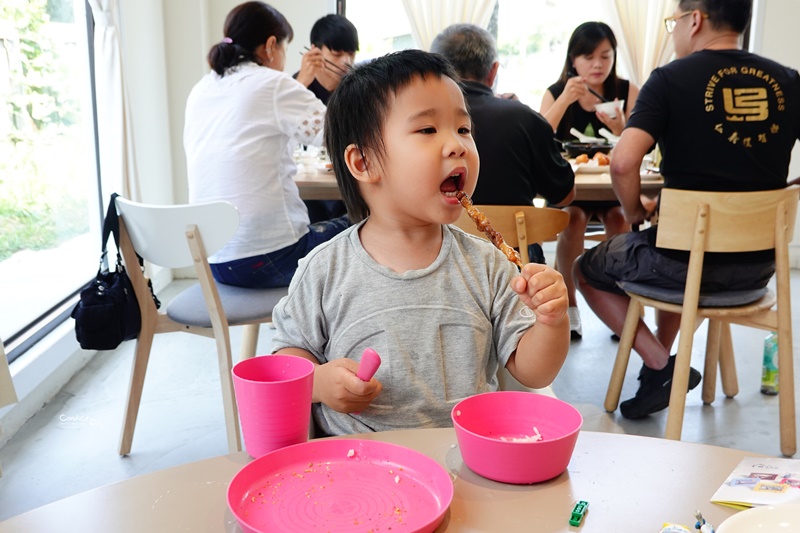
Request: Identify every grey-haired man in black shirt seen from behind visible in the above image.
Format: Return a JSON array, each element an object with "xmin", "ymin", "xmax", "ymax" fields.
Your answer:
[{"xmin": 431, "ymin": 24, "xmax": 575, "ymax": 262}]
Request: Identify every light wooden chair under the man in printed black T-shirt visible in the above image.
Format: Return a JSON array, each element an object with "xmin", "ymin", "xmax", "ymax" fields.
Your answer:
[{"xmin": 605, "ymin": 186, "xmax": 800, "ymax": 456}]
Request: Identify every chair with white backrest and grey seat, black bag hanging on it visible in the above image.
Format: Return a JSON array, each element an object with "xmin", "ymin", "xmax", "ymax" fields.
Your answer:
[{"xmin": 112, "ymin": 198, "xmax": 287, "ymax": 455}]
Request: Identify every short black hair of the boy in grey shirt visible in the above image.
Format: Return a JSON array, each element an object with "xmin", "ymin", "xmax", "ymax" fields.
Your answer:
[{"xmin": 325, "ymin": 50, "xmax": 458, "ymax": 223}]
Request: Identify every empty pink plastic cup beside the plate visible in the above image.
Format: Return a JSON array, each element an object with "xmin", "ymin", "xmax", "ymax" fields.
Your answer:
[{"xmin": 233, "ymin": 354, "xmax": 314, "ymax": 458}]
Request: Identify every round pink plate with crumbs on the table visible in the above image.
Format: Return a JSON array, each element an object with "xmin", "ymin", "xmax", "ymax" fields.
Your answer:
[{"xmin": 228, "ymin": 439, "xmax": 453, "ymax": 533}]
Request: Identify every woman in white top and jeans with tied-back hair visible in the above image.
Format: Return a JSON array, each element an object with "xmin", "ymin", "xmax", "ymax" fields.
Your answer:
[{"xmin": 189, "ymin": 2, "xmax": 350, "ymax": 287}]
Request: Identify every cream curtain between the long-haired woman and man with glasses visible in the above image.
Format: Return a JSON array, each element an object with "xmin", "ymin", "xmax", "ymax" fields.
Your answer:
[{"xmin": 606, "ymin": 0, "xmax": 675, "ymax": 87}]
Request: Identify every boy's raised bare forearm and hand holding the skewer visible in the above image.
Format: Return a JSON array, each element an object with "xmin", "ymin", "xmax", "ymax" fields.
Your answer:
[{"xmin": 506, "ymin": 263, "xmax": 570, "ymax": 389}]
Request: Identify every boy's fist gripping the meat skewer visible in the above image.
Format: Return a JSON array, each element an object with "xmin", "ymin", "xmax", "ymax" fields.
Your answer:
[{"xmin": 511, "ymin": 263, "xmax": 569, "ymax": 326}]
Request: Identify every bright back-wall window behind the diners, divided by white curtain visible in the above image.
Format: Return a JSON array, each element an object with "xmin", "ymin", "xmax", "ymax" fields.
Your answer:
[{"xmin": 346, "ymin": 0, "xmax": 612, "ymax": 110}]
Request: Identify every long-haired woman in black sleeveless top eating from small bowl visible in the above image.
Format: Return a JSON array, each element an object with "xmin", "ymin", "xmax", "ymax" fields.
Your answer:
[{"xmin": 540, "ymin": 22, "xmax": 639, "ymax": 339}]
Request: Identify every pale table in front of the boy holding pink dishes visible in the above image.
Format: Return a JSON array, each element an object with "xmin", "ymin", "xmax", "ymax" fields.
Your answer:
[{"xmin": 0, "ymin": 428, "xmax": 756, "ymax": 533}]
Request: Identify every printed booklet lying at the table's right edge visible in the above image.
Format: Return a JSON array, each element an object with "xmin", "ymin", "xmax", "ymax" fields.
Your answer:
[{"xmin": 711, "ymin": 457, "xmax": 800, "ymax": 509}]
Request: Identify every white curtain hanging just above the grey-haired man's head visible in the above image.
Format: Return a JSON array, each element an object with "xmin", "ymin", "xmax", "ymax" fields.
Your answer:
[{"xmin": 403, "ymin": 0, "xmax": 497, "ymax": 50}]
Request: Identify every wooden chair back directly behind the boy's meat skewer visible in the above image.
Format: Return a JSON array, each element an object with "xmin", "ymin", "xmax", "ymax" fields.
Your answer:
[{"xmin": 455, "ymin": 205, "xmax": 569, "ymax": 264}]
